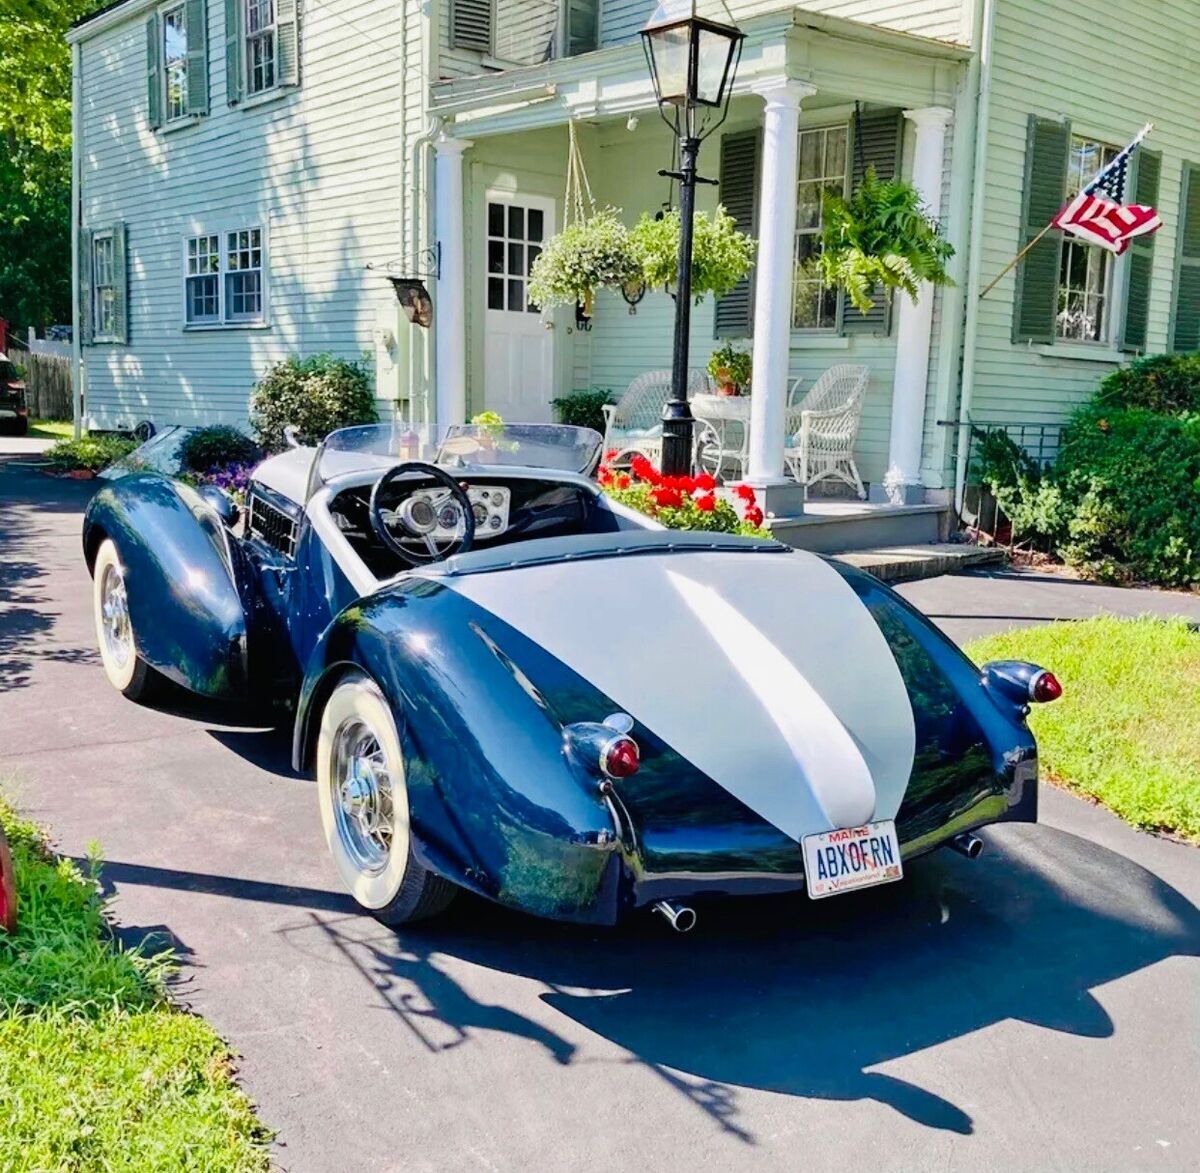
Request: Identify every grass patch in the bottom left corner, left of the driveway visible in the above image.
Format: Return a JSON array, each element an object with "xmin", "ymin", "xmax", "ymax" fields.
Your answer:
[{"xmin": 0, "ymin": 800, "xmax": 269, "ymax": 1173}]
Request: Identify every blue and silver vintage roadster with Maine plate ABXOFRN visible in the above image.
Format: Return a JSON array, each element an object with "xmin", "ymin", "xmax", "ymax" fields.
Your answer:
[{"xmin": 83, "ymin": 425, "xmax": 1060, "ymax": 930}]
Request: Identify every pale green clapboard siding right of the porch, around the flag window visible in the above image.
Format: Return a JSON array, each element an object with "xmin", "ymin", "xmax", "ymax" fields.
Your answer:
[{"xmin": 971, "ymin": 0, "xmax": 1200, "ymax": 431}]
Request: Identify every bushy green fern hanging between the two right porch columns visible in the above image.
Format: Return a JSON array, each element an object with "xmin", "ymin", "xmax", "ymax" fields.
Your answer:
[{"xmin": 821, "ymin": 168, "xmax": 954, "ymax": 314}]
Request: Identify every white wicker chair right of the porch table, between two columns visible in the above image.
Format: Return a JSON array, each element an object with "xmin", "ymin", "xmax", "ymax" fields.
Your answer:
[{"xmin": 784, "ymin": 363, "xmax": 871, "ymax": 499}]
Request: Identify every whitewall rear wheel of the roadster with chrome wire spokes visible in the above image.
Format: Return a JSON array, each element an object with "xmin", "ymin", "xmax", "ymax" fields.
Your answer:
[{"xmin": 317, "ymin": 674, "xmax": 455, "ymax": 925}]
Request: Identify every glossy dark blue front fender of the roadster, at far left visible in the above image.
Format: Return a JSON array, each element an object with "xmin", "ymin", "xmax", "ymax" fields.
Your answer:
[{"xmin": 83, "ymin": 473, "xmax": 248, "ymax": 698}]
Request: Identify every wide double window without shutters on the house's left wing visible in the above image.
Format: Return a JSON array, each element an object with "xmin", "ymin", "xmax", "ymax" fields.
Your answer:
[{"xmin": 184, "ymin": 228, "xmax": 266, "ymax": 326}]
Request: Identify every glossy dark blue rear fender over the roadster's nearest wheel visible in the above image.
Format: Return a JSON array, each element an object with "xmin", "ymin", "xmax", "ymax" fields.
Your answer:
[{"xmin": 293, "ymin": 582, "xmax": 620, "ymax": 924}]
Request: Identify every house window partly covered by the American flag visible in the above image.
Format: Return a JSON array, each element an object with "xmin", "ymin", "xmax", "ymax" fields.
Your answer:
[{"xmin": 1055, "ymin": 136, "xmax": 1118, "ymax": 342}]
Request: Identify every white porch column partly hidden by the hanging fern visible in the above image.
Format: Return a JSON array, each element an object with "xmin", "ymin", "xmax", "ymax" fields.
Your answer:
[{"xmin": 872, "ymin": 106, "xmax": 954, "ymax": 505}]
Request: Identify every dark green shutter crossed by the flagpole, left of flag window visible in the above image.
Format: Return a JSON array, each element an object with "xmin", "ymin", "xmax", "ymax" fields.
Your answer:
[{"xmin": 1013, "ymin": 114, "xmax": 1070, "ymax": 343}]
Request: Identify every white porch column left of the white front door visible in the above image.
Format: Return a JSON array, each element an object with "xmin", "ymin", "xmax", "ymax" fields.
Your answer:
[{"xmin": 433, "ymin": 131, "xmax": 472, "ymax": 423}]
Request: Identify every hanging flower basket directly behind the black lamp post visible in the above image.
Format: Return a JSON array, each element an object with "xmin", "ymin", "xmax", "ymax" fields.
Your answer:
[{"xmin": 630, "ymin": 207, "xmax": 756, "ymax": 302}]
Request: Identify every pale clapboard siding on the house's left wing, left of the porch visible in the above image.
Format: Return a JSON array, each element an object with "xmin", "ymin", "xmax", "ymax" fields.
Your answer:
[{"xmin": 79, "ymin": 0, "xmax": 406, "ymax": 427}]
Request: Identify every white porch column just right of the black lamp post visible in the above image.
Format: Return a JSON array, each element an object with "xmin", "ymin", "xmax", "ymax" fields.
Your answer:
[{"xmin": 746, "ymin": 82, "xmax": 816, "ymax": 517}]
